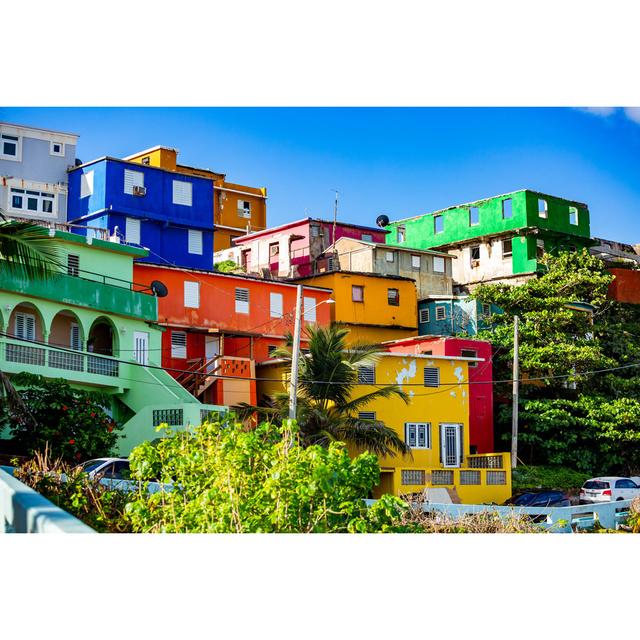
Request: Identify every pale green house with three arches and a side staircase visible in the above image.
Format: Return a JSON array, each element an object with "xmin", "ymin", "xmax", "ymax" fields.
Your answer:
[{"xmin": 0, "ymin": 229, "xmax": 224, "ymax": 455}]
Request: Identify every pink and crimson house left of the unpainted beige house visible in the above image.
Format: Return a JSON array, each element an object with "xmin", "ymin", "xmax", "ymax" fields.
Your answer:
[{"xmin": 215, "ymin": 218, "xmax": 389, "ymax": 277}]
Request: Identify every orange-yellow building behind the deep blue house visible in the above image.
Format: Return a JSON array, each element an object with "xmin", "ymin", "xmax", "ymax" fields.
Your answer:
[{"xmin": 124, "ymin": 146, "xmax": 267, "ymax": 252}]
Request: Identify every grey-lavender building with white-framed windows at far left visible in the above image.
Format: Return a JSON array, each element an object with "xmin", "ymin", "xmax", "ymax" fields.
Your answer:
[{"xmin": 0, "ymin": 122, "xmax": 78, "ymax": 224}]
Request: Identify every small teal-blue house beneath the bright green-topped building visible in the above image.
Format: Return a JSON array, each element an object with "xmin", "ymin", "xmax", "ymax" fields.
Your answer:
[{"xmin": 418, "ymin": 296, "xmax": 502, "ymax": 336}]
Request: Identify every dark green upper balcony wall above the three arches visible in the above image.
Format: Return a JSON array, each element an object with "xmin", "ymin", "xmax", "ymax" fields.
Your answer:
[{"xmin": 0, "ymin": 262, "xmax": 158, "ymax": 321}]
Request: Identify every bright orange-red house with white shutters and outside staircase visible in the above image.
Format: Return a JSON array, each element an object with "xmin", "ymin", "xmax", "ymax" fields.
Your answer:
[{"xmin": 134, "ymin": 262, "xmax": 331, "ymax": 406}]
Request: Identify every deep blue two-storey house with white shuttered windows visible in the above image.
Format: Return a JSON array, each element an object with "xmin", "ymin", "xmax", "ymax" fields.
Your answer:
[{"xmin": 69, "ymin": 157, "xmax": 213, "ymax": 269}]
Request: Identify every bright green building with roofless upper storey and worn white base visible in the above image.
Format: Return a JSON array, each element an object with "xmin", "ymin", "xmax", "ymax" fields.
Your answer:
[{"xmin": 386, "ymin": 189, "xmax": 593, "ymax": 289}]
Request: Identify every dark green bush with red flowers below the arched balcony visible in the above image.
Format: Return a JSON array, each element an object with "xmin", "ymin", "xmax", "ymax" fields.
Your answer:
[{"xmin": 0, "ymin": 373, "xmax": 120, "ymax": 463}]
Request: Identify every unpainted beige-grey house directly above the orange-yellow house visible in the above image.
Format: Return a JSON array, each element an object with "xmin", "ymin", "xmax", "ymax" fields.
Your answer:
[{"xmin": 320, "ymin": 237, "xmax": 454, "ymax": 298}]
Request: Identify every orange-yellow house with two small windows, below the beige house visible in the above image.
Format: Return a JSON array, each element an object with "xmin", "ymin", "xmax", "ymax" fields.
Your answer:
[{"xmin": 296, "ymin": 271, "xmax": 418, "ymax": 344}]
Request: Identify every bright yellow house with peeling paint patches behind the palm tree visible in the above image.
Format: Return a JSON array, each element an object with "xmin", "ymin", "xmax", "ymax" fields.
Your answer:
[{"xmin": 256, "ymin": 353, "xmax": 511, "ymax": 504}]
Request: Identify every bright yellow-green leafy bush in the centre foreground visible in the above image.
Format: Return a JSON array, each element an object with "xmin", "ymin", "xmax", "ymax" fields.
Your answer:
[{"xmin": 127, "ymin": 416, "xmax": 403, "ymax": 533}]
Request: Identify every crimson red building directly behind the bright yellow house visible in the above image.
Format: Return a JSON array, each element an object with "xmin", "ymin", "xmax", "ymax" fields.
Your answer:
[{"xmin": 381, "ymin": 336, "xmax": 494, "ymax": 453}]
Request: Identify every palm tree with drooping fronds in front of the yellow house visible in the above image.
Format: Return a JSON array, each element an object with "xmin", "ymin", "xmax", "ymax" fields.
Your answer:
[{"xmin": 235, "ymin": 325, "xmax": 411, "ymax": 456}]
